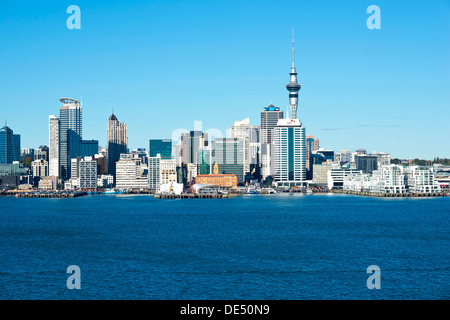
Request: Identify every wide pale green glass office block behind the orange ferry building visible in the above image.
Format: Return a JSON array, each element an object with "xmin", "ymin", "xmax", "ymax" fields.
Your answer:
[{"xmin": 211, "ymin": 138, "xmax": 245, "ymax": 182}]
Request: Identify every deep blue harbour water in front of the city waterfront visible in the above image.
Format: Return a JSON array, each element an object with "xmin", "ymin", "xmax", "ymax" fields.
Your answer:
[{"xmin": 0, "ymin": 194, "xmax": 450, "ymax": 300}]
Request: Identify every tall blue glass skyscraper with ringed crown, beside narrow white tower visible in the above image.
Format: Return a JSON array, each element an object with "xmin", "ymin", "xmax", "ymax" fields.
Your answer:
[{"xmin": 59, "ymin": 98, "xmax": 82, "ymax": 180}]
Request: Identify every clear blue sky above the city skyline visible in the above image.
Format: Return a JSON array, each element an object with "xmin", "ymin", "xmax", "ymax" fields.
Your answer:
[{"xmin": 0, "ymin": 0, "xmax": 450, "ymax": 159}]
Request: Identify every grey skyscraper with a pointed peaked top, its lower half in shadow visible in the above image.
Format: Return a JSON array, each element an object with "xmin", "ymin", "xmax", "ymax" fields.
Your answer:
[{"xmin": 108, "ymin": 113, "xmax": 128, "ymax": 176}]
